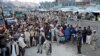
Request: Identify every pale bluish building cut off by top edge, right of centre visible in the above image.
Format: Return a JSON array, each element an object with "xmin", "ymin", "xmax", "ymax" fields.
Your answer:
[{"xmin": 56, "ymin": 0, "xmax": 91, "ymax": 6}]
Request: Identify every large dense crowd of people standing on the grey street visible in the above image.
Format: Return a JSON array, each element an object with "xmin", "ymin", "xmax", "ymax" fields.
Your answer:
[{"xmin": 0, "ymin": 13, "xmax": 97, "ymax": 56}]
